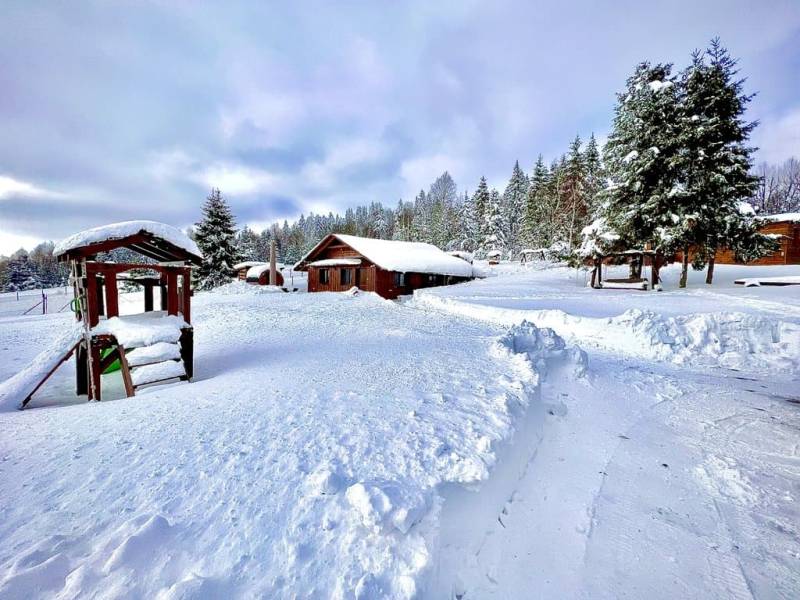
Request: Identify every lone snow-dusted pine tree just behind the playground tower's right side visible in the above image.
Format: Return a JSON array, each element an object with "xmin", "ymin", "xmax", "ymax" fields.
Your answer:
[{"xmin": 195, "ymin": 188, "xmax": 239, "ymax": 290}]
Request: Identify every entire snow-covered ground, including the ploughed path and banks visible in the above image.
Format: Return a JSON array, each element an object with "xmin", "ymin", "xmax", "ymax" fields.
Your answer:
[{"xmin": 0, "ymin": 265, "xmax": 800, "ymax": 599}]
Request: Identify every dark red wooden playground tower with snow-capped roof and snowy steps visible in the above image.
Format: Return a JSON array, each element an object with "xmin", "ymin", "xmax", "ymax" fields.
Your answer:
[{"xmin": 21, "ymin": 221, "xmax": 202, "ymax": 407}]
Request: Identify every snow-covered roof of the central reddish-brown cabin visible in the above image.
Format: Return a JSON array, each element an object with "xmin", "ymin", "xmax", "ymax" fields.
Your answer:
[{"xmin": 295, "ymin": 233, "xmax": 474, "ymax": 277}]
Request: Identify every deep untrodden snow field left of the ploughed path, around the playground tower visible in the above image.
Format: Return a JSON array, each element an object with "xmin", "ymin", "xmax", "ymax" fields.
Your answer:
[{"xmin": 0, "ymin": 283, "xmax": 564, "ymax": 598}]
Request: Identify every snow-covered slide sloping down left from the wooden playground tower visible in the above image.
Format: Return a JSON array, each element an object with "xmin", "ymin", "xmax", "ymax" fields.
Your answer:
[{"xmin": 0, "ymin": 323, "xmax": 84, "ymax": 410}]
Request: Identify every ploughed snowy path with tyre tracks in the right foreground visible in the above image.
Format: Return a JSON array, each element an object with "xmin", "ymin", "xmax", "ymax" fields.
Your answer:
[{"xmin": 413, "ymin": 268, "xmax": 800, "ymax": 600}]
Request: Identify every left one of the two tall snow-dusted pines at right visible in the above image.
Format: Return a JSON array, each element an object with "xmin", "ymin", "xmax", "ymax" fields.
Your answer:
[{"xmin": 596, "ymin": 62, "xmax": 690, "ymax": 274}]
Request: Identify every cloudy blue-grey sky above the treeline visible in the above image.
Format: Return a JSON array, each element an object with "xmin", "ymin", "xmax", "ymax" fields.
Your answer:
[{"xmin": 0, "ymin": 0, "xmax": 800, "ymax": 254}]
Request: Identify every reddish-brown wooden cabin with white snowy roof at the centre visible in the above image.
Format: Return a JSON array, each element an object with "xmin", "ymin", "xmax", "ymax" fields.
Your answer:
[{"xmin": 294, "ymin": 233, "xmax": 475, "ymax": 299}]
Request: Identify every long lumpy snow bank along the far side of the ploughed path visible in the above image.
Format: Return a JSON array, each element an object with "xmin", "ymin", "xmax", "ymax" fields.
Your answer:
[{"xmin": 413, "ymin": 290, "xmax": 800, "ymax": 371}]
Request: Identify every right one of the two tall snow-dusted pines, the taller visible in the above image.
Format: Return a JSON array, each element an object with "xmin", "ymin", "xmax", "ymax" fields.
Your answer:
[{"xmin": 679, "ymin": 39, "xmax": 775, "ymax": 287}]
